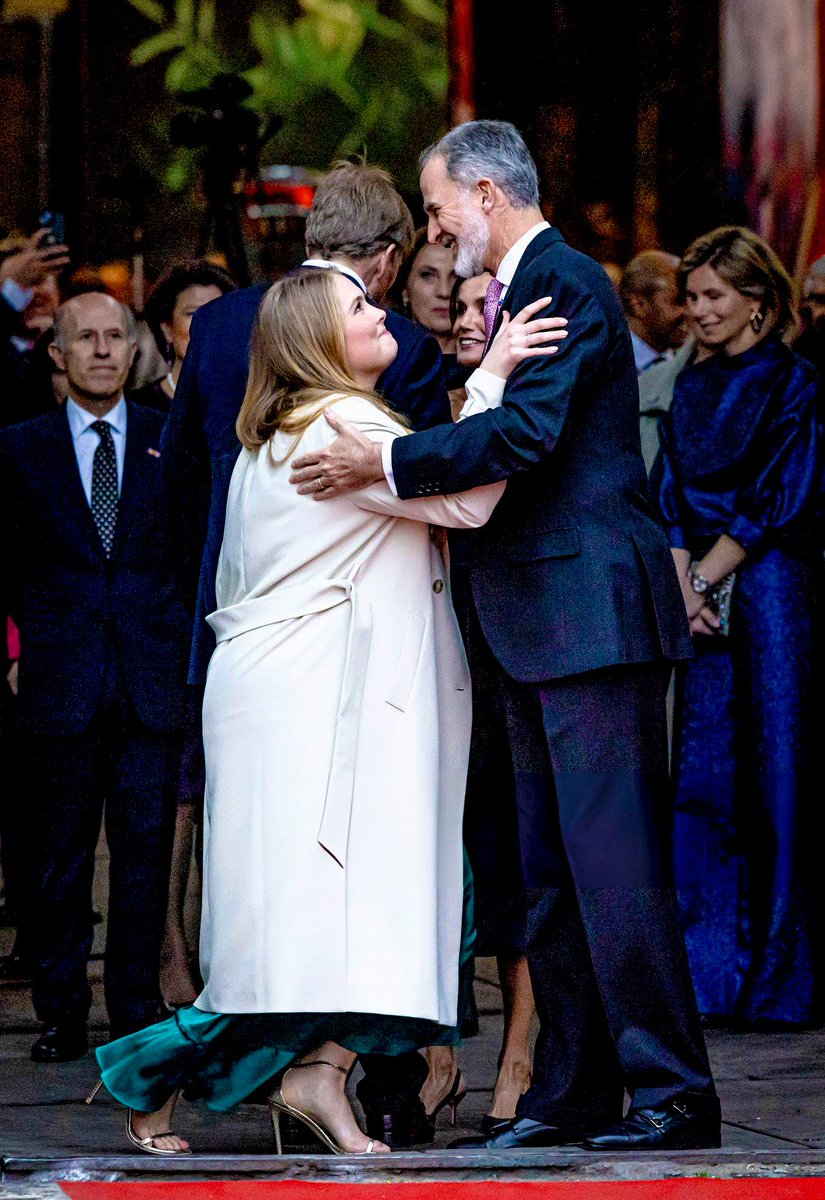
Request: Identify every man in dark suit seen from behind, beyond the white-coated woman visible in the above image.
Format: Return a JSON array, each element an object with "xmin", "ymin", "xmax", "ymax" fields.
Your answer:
[{"xmin": 163, "ymin": 163, "xmax": 450, "ymax": 1147}]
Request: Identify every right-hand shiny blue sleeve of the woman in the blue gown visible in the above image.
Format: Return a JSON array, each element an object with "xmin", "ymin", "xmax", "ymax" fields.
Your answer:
[{"xmin": 728, "ymin": 380, "xmax": 821, "ymax": 553}]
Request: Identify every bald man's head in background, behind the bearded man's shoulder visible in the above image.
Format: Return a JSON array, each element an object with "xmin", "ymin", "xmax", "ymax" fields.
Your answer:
[{"xmin": 619, "ymin": 250, "xmax": 687, "ymax": 354}]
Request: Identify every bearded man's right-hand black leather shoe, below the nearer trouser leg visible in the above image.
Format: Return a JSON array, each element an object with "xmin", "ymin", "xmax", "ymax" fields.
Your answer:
[{"xmin": 582, "ymin": 1096, "xmax": 722, "ymax": 1153}]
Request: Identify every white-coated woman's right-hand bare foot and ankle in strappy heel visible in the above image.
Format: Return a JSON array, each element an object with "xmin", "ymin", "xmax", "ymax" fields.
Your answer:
[{"xmin": 281, "ymin": 1042, "xmax": 390, "ymax": 1154}]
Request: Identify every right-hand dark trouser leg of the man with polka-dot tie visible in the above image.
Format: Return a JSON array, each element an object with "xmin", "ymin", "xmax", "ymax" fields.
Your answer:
[{"xmin": 106, "ymin": 713, "xmax": 180, "ymax": 1037}]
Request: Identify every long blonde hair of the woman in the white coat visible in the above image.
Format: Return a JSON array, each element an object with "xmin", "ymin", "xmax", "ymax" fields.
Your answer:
[{"xmin": 235, "ymin": 268, "xmax": 404, "ymax": 454}]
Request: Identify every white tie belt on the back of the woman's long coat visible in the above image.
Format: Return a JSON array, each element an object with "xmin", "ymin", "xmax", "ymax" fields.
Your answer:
[{"xmin": 206, "ymin": 564, "xmax": 373, "ymax": 868}]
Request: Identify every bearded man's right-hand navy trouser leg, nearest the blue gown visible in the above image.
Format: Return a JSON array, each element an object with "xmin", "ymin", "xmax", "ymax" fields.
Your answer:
[{"xmin": 538, "ymin": 665, "xmax": 713, "ymax": 1105}]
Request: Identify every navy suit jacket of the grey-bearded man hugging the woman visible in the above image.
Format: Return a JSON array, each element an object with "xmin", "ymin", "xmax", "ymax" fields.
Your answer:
[{"xmin": 392, "ymin": 228, "xmax": 691, "ymax": 683}]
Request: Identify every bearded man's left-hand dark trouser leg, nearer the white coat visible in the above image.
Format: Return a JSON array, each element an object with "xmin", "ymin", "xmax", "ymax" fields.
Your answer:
[{"xmin": 501, "ymin": 679, "xmax": 624, "ymax": 1128}]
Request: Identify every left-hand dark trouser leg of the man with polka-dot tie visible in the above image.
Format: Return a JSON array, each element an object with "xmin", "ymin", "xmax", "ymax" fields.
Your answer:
[{"xmin": 28, "ymin": 718, "xmax": 104, "ymax": 1025}]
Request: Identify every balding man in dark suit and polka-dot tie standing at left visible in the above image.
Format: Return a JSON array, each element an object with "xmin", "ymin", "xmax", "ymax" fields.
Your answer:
[{"xmin": 0, "ymin": 293, "xmax": 192, "ymax": 1062}]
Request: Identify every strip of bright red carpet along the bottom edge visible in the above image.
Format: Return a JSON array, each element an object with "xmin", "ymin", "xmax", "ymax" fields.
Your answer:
[{"xmin": 60, "ymin": 1178, "xmax": 825, "ymax": 1200}]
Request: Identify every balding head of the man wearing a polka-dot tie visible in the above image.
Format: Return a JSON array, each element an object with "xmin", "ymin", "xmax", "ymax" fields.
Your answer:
[{"xmin": 49, "ymin": 292, "xmax": 137, "ymax": 416}]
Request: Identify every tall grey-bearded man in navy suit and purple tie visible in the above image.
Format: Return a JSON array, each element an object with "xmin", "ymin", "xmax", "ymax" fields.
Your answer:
[{"xmin": 293, "ymin": 121, "xmax": 719, "ymax": 1150}]
